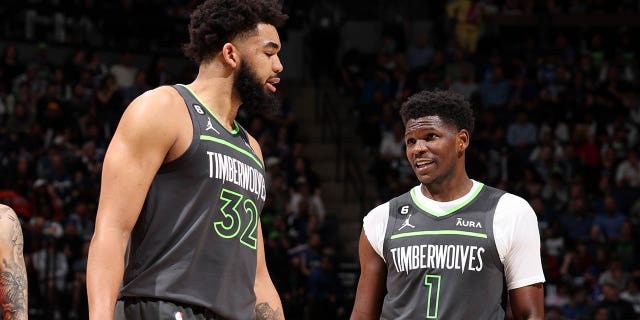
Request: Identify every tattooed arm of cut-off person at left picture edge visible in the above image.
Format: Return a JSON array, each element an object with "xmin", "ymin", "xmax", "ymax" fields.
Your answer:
[{"xmin": 0, "ymin": 204, "xmax": 28, "ymax": 320}]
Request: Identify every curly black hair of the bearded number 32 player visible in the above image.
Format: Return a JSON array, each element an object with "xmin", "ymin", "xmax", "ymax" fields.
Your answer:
[{"xmin": 183, "ymin": 0, "xmax": 288, "ymax": 64}]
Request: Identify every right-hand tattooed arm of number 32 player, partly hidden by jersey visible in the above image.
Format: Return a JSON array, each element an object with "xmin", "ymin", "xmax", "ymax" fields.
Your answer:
[{"xmin": 249, "ymin": 136, "xmax": 284, "ymax": 320}]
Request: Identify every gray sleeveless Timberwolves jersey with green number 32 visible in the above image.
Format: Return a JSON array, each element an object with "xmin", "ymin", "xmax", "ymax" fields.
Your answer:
[{"xmin": 120, "ymin": 85, "xmax": 266, "ymax": 320}]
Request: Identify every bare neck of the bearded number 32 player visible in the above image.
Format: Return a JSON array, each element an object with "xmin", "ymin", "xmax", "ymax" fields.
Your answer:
[{"xmin": 188, "ymin": 60, "xmax": 242, "ymax": 130}]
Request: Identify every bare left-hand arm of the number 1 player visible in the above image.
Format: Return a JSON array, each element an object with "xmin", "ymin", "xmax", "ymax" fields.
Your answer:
[{"xmin": 351, "ymin": 231, "xmax": 387, "ymax": 320}]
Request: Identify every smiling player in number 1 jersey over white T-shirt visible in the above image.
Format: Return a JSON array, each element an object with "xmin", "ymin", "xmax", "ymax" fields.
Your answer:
[{"xmin": 351, "ymin": 91, "xmax": 544, "ymax": 320}]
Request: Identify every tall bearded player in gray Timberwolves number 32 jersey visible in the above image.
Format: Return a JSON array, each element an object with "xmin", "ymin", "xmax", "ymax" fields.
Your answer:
[{"xmin": 87, "ymin": 0, "xmax": 287, "ymax": 320}]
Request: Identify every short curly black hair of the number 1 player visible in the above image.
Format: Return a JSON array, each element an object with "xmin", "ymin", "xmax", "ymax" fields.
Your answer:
[{"xmin": 400, "ymin": 89, "xmax": 475, "ymax": 135}]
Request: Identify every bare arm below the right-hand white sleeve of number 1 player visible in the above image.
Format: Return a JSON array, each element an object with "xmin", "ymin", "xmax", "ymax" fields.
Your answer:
[{"xmin": 509, "ymin": 283, "xmax": 544, "ymax": 320}]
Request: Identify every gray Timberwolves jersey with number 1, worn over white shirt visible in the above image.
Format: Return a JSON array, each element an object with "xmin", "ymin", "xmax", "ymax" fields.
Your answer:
[{"xmin": 381, "ymin": 185, "xmax": 506, "ymax": 320}]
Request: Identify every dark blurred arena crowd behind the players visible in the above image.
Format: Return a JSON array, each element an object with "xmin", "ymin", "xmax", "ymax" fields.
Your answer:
[{"xmin": 0, "ymin": 0, "xmax": 640, "ymax": 320}]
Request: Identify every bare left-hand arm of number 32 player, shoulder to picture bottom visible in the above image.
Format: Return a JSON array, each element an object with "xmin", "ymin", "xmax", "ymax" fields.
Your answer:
[{"xmin": 87, "ymin": 88, "xmax": 186, "ymax": 319}]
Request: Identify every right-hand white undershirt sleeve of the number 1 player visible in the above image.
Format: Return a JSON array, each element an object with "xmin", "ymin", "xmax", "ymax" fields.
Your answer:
[{"xmin": 493, "ymin": 193, "xmax": 545, "ymax": 290}]
